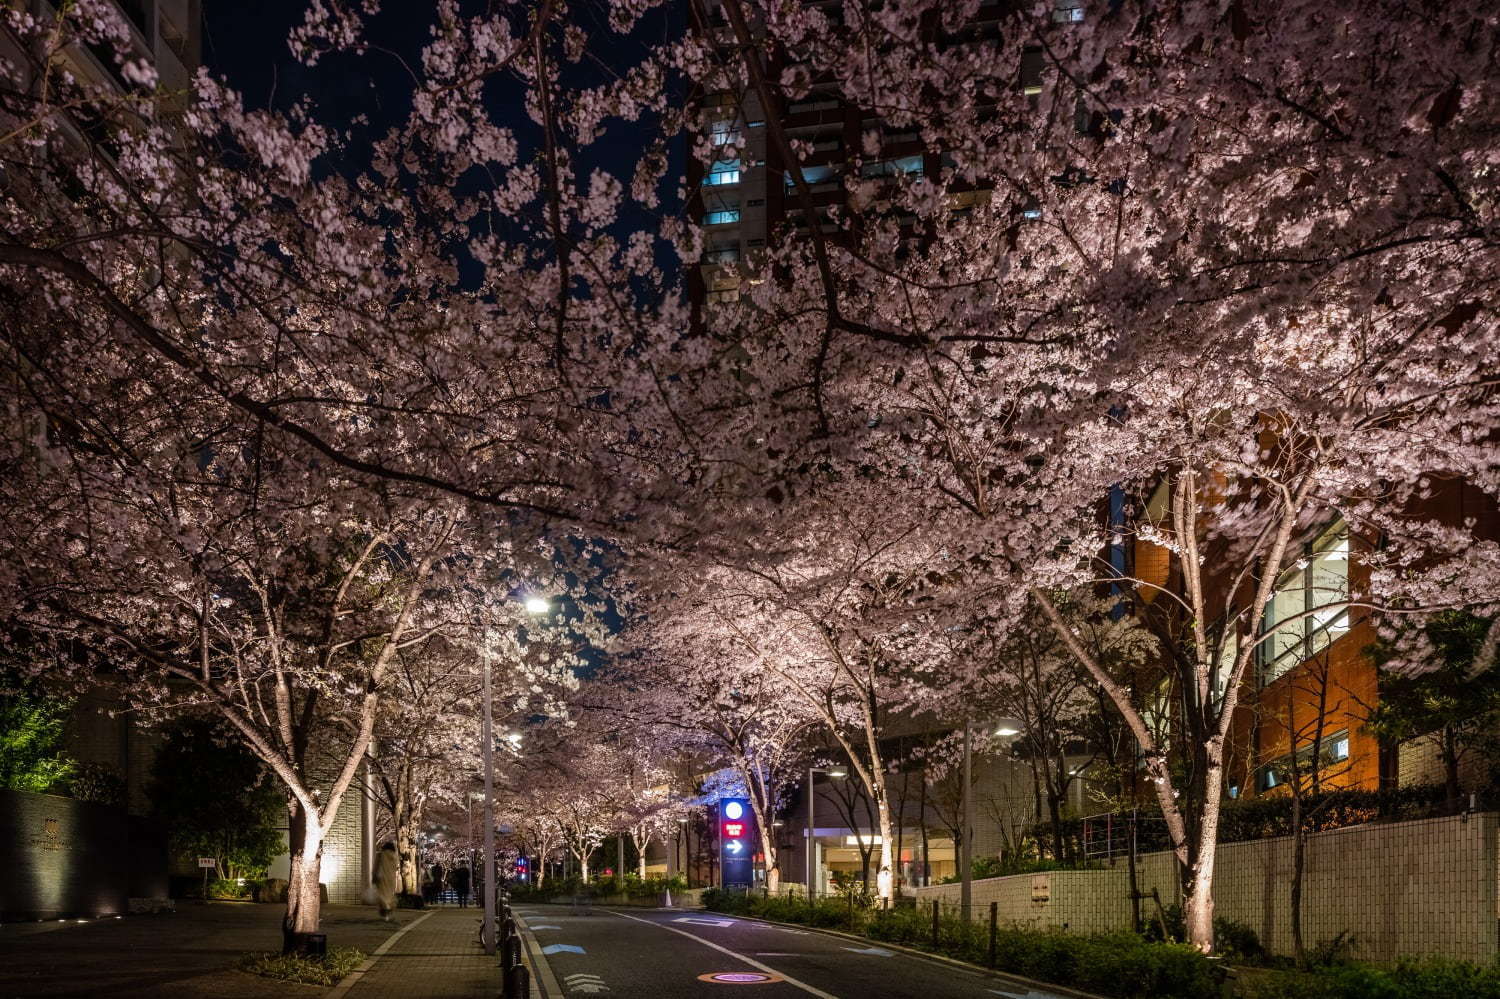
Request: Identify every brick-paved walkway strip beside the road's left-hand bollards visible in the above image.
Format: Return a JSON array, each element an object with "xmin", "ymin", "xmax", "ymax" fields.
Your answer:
[{"xmin": 329, "ymin": 908, "xmax": 500, "ymax": 999}]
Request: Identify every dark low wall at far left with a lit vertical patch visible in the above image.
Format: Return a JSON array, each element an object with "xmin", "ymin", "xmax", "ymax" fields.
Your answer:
[{"xmin": 0, "ymin": 791, "xmax": 167, "ymax": 921}]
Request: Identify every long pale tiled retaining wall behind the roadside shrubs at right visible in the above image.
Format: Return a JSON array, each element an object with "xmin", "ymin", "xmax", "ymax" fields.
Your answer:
[{"xmin": 912, "ymin": 812, "xmax": 1500, "ymax": 963}]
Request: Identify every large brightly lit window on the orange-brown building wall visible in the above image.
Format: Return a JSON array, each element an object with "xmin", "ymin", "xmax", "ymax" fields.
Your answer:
[{"xmin": 1260, "ymin": 519, "xmax": 1349, "ymax": 684}]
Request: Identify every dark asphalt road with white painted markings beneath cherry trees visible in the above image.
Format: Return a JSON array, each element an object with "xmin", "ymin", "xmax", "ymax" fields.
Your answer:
[{"xmin": 516, "ymin": 905, "xmax": 1062, "ymax": 999}]
